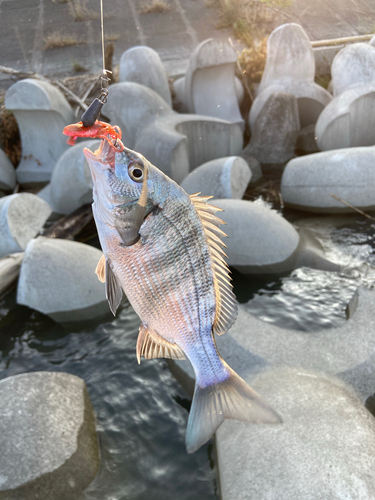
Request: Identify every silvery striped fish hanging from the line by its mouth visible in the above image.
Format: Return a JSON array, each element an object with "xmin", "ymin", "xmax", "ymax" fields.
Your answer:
[{"xmin": 64, "ymin": 122, "xmax": 281, "ymax": 453}]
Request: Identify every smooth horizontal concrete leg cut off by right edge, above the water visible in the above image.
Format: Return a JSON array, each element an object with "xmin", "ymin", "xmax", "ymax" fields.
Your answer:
[{"xmin": 281, "ymin": 147, "xmax": 375, "ymax": 213}]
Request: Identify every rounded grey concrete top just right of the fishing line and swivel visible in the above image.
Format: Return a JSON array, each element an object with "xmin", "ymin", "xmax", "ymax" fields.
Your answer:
[{"xmin": 120, "ymin": 46, "xmax": 172, "ymax": 106}]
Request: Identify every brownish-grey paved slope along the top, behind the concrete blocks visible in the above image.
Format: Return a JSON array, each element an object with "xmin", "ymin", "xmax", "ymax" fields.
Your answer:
[{"xmin": 0, "ymin": 0, "xmax": 375, "ymax": 86}]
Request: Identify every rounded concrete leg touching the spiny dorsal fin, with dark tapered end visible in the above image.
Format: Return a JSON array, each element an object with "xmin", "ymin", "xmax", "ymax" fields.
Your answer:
[{"xmin": 211, "ymin": 199, "xmax": 341, "ymax": 275}]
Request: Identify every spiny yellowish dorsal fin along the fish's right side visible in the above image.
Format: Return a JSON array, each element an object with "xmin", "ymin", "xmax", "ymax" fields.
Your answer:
[{"xmin": 190, "ymin": 193, "xmax": 237, "ymax": 335}]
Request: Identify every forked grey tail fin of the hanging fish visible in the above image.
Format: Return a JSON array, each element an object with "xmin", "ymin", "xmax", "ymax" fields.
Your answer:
[{"xmin": 186, "ymin": 361, "xmax": 282, "ymax": 453}]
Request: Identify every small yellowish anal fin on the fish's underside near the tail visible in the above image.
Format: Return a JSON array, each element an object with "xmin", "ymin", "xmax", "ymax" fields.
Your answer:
[{"xmin": 137, "ymin": 325, "xmax": 185, "ymax": 363}]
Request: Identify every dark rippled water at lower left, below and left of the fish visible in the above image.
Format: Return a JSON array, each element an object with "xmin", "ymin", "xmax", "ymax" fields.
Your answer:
[{"xmin": 0, "ymin": 297, "xmax": 218, "ymax": 500}]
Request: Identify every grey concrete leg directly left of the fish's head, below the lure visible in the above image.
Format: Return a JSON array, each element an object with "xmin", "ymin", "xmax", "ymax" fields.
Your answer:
[{"xmin": 38, "ymin": 140, "xmax": 100, "ymax": 215}]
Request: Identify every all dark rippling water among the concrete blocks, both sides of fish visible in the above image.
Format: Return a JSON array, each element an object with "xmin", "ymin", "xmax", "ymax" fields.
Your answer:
[{"xmin": 0, "ymin": 213, "xmax": 375, "ymax": 500}]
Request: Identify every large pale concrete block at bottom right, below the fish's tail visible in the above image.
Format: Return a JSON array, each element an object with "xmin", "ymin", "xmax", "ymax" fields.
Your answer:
[{"xmin": 216, "ymin": 368, "xmax": 375, "ymax": 500}]
